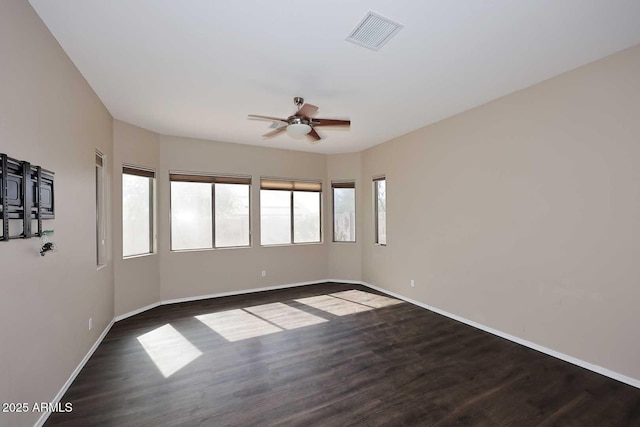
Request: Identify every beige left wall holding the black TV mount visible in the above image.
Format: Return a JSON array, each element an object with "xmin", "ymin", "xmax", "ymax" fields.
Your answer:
[{"xmin": 0, "ymin": 0, "xmax": 113, "ymax": 427}]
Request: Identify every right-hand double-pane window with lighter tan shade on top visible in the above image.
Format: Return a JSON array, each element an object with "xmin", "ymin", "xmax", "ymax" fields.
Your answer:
[{"xmin": 260, "ymin": 179, "xmax": 322, "ymax": 246}]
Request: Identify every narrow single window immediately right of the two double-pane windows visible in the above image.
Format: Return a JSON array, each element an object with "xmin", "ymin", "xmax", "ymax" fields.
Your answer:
[{"xmin": 331, "ymin": 182, "xmax": 356, "ymax": 242}]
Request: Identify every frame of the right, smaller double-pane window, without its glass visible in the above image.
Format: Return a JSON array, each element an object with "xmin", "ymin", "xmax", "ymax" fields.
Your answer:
[{"xmin": 260, "ymin": 177, "xmax": 324, "ymax": 247}]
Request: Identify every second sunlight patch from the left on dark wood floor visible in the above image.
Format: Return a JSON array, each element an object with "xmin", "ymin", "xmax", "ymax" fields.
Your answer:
[{"xmin": 196, "ymin": 309, "xmax": 282, "ymax": 342}]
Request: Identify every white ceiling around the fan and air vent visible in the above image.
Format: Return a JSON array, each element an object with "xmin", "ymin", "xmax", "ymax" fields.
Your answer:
[{"xmin": 30, "ymin": 0, "xmax": 640, "ymax": 153}]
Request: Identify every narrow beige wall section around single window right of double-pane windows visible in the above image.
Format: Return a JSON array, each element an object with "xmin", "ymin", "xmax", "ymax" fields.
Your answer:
[{"xmin": 325, "ymin": 153, "xmax": 362, "ymax": 281}]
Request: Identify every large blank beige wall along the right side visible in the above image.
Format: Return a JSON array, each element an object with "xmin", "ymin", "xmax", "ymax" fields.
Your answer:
[{"xmin": 361, "ymin": 46, "xmax": 640, "ymax": 379}]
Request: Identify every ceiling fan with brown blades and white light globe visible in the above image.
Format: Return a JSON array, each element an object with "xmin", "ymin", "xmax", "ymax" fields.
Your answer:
[{"xmin": 248, "ymin": 96, "xmax": 351, "ymax": 143}]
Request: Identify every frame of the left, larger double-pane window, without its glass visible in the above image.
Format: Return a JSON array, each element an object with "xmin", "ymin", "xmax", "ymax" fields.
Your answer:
[{"xmin": 169, "ymin": 171, "xmax": 253, "ymax": 252}]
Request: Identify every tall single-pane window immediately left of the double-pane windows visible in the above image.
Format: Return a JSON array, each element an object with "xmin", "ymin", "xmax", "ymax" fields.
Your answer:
[{"xmin": 122, "ymin": 166, "xmax": 156, "ymax": 258}]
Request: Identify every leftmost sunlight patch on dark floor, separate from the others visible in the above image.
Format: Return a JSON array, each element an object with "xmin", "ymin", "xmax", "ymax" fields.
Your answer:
[{"xmin": 137, "ymin": 324, "xmax": 202, "ymax": 378}]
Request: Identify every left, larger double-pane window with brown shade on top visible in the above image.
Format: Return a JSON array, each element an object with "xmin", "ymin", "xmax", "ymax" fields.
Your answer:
[{"xmin": 169, "ymin": 173, "xmax": 251, "ymax": 251}]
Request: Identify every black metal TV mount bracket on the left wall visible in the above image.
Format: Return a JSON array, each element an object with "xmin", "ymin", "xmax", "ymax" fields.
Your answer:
[{"xmin": 0, "ymin": 154, "xmax": 55, "ymax": 241}]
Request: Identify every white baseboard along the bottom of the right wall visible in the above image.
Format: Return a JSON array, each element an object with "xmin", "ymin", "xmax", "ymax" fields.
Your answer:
[{"xmin": 359, "ymin": 282, "xmax": 640, "ymax": 388}]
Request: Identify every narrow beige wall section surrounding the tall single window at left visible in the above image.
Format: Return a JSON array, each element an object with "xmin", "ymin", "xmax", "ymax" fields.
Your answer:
[{"xmin": 112, "ymin": 120, "xmax": 163, "ymax": 316}]
